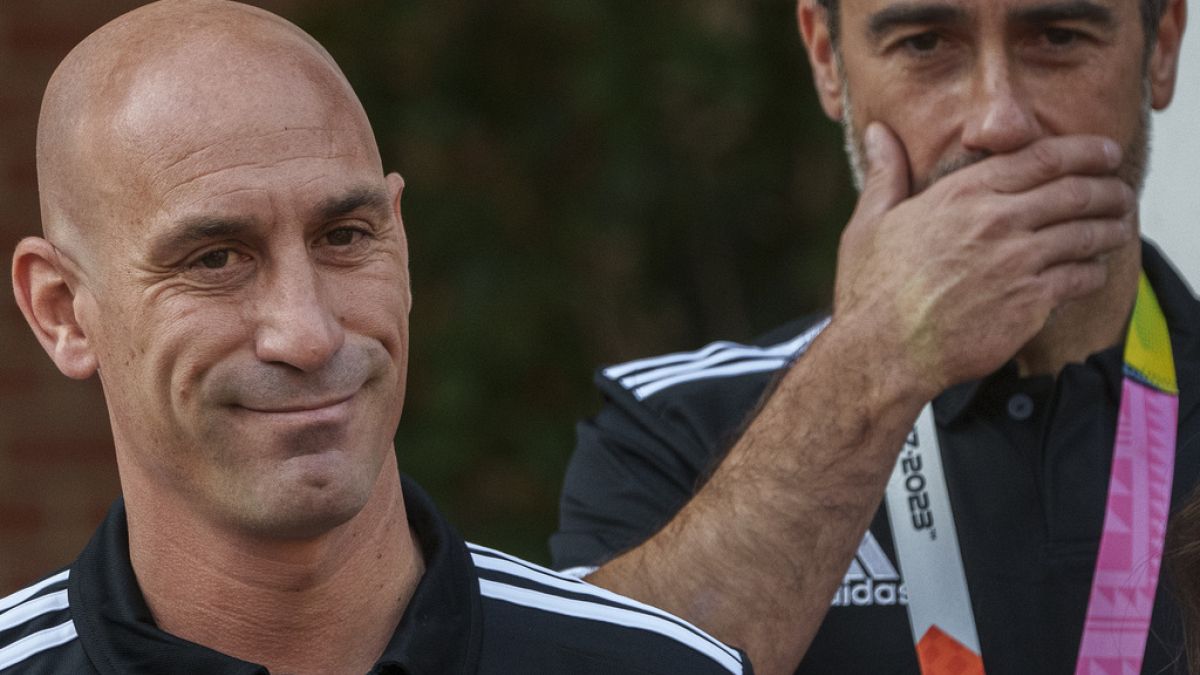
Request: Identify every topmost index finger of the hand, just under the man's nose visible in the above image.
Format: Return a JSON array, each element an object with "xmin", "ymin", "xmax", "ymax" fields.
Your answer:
[{"xmin": 976, "ymin": 135, "xmax": 1122, "ymax": 192}]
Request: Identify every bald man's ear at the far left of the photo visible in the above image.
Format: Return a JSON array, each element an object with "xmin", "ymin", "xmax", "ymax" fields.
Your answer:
[{"xmin": 12, "ymin": 237, "xmax": 97, "ymax": 380}]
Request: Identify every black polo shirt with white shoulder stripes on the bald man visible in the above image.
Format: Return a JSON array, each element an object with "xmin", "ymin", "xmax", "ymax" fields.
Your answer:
[{"xmin": 0, "ymin": 479, "xmax": 751, "ymax": 675}]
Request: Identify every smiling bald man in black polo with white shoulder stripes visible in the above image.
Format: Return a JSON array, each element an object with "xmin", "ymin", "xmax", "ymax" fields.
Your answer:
[{"xmin": 0, "ymin": 0, "xmax": 750, "ymax": 675}]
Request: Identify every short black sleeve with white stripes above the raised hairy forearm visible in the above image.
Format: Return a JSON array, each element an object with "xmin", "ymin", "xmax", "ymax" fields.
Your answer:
[{"xmin": 550, "ymin": 315, "xmax": 823, "ymax": 566}]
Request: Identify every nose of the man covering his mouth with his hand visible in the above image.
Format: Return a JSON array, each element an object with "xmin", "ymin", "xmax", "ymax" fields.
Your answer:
[{"xmin": 962, "ymin": 54, "xmax": 1042, "ymax": 154}]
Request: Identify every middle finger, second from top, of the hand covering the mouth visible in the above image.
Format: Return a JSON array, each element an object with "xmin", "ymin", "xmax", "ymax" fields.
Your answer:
[{"xmin": 996, "ymin": 175, "xmax": 1138, "ymax": 229}]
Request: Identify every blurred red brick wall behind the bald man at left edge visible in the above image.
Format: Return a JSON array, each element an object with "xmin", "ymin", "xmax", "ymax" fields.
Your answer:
[{"xmin": 0, "ymin": 0, "xmax": 302, "ymax": 596}]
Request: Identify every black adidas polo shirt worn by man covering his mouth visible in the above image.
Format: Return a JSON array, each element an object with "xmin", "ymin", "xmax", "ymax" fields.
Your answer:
[{"xmin": 551, "ymin": 239, "xmax": 1200, "ymax": 675}]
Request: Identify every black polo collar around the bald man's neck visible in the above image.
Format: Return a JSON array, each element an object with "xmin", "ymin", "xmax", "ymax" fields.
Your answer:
[{"xmin": 67, "ymin": 478, "xmax": 482, "ymax": 675}]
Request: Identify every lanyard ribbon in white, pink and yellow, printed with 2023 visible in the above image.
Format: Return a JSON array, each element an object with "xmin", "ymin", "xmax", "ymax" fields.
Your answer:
[{"xmin": 886, "ymin": 273, "xmax": 1178, "ymax": 675}]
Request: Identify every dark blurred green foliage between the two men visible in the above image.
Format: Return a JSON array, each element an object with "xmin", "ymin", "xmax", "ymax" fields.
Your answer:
[{"xmin": 299, "ymin": 0, "xmax": 853, "ymax": 560}]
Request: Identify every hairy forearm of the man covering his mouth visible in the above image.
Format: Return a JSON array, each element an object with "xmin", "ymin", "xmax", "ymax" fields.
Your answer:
[{"xmin": 589, "ymin": 321, "xmax": 930, "ymax": 674}]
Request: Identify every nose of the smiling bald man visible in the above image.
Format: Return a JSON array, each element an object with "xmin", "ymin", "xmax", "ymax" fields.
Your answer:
[{"xmin": 254, "ymin": 255, "xmax": 346, "ymax": 372}]
